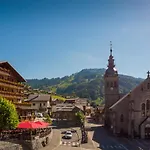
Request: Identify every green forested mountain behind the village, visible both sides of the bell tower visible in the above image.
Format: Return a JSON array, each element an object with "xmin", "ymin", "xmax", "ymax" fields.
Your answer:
[{"xmin": 27, "ymin": 69, "xmax": 143, "ymax": 101}]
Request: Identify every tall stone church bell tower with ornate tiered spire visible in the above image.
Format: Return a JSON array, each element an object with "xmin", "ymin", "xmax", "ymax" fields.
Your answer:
[{"xmin": 104, "ymin": 42, "xmax": 119, "ymax": 126}]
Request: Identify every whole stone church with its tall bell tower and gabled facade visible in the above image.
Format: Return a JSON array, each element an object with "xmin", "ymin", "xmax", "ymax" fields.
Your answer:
[{"xmin": 104, "ymin": 42, "xmax": 150, "ymax": 139}]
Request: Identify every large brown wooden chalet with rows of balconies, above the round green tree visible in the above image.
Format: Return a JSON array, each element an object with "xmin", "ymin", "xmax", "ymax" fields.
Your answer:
[{"xmin": 0, "ymin": 62, "xmax": 26, "ymax": 104}]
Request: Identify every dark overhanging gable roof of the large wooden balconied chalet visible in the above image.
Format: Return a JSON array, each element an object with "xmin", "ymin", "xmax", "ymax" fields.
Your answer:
[{"xmin": 0, "ymin": 61, "xmax": 26, "ymax": 82}]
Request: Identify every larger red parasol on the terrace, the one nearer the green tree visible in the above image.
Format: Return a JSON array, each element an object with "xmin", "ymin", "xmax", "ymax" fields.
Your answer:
[{"xmin": 17, "ymin": 121, "xmax": 43, "ymax": 129}]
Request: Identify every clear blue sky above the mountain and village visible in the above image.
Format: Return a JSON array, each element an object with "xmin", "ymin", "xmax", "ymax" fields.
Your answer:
[{"xmin": 0, "ymin": 0, "xmax": 150, "ymax": 79}]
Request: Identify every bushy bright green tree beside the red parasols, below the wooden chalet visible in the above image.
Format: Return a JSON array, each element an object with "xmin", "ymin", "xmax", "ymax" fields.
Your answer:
[{"xmin": 0, "ymin": 97, "xmax": 19, "ymax": 130}]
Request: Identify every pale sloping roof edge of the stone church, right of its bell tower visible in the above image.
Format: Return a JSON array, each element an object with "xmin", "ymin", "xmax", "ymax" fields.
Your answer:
[{"xmin": 109, "ymin": 78, "xmax": 148, "ymax": 109}]
